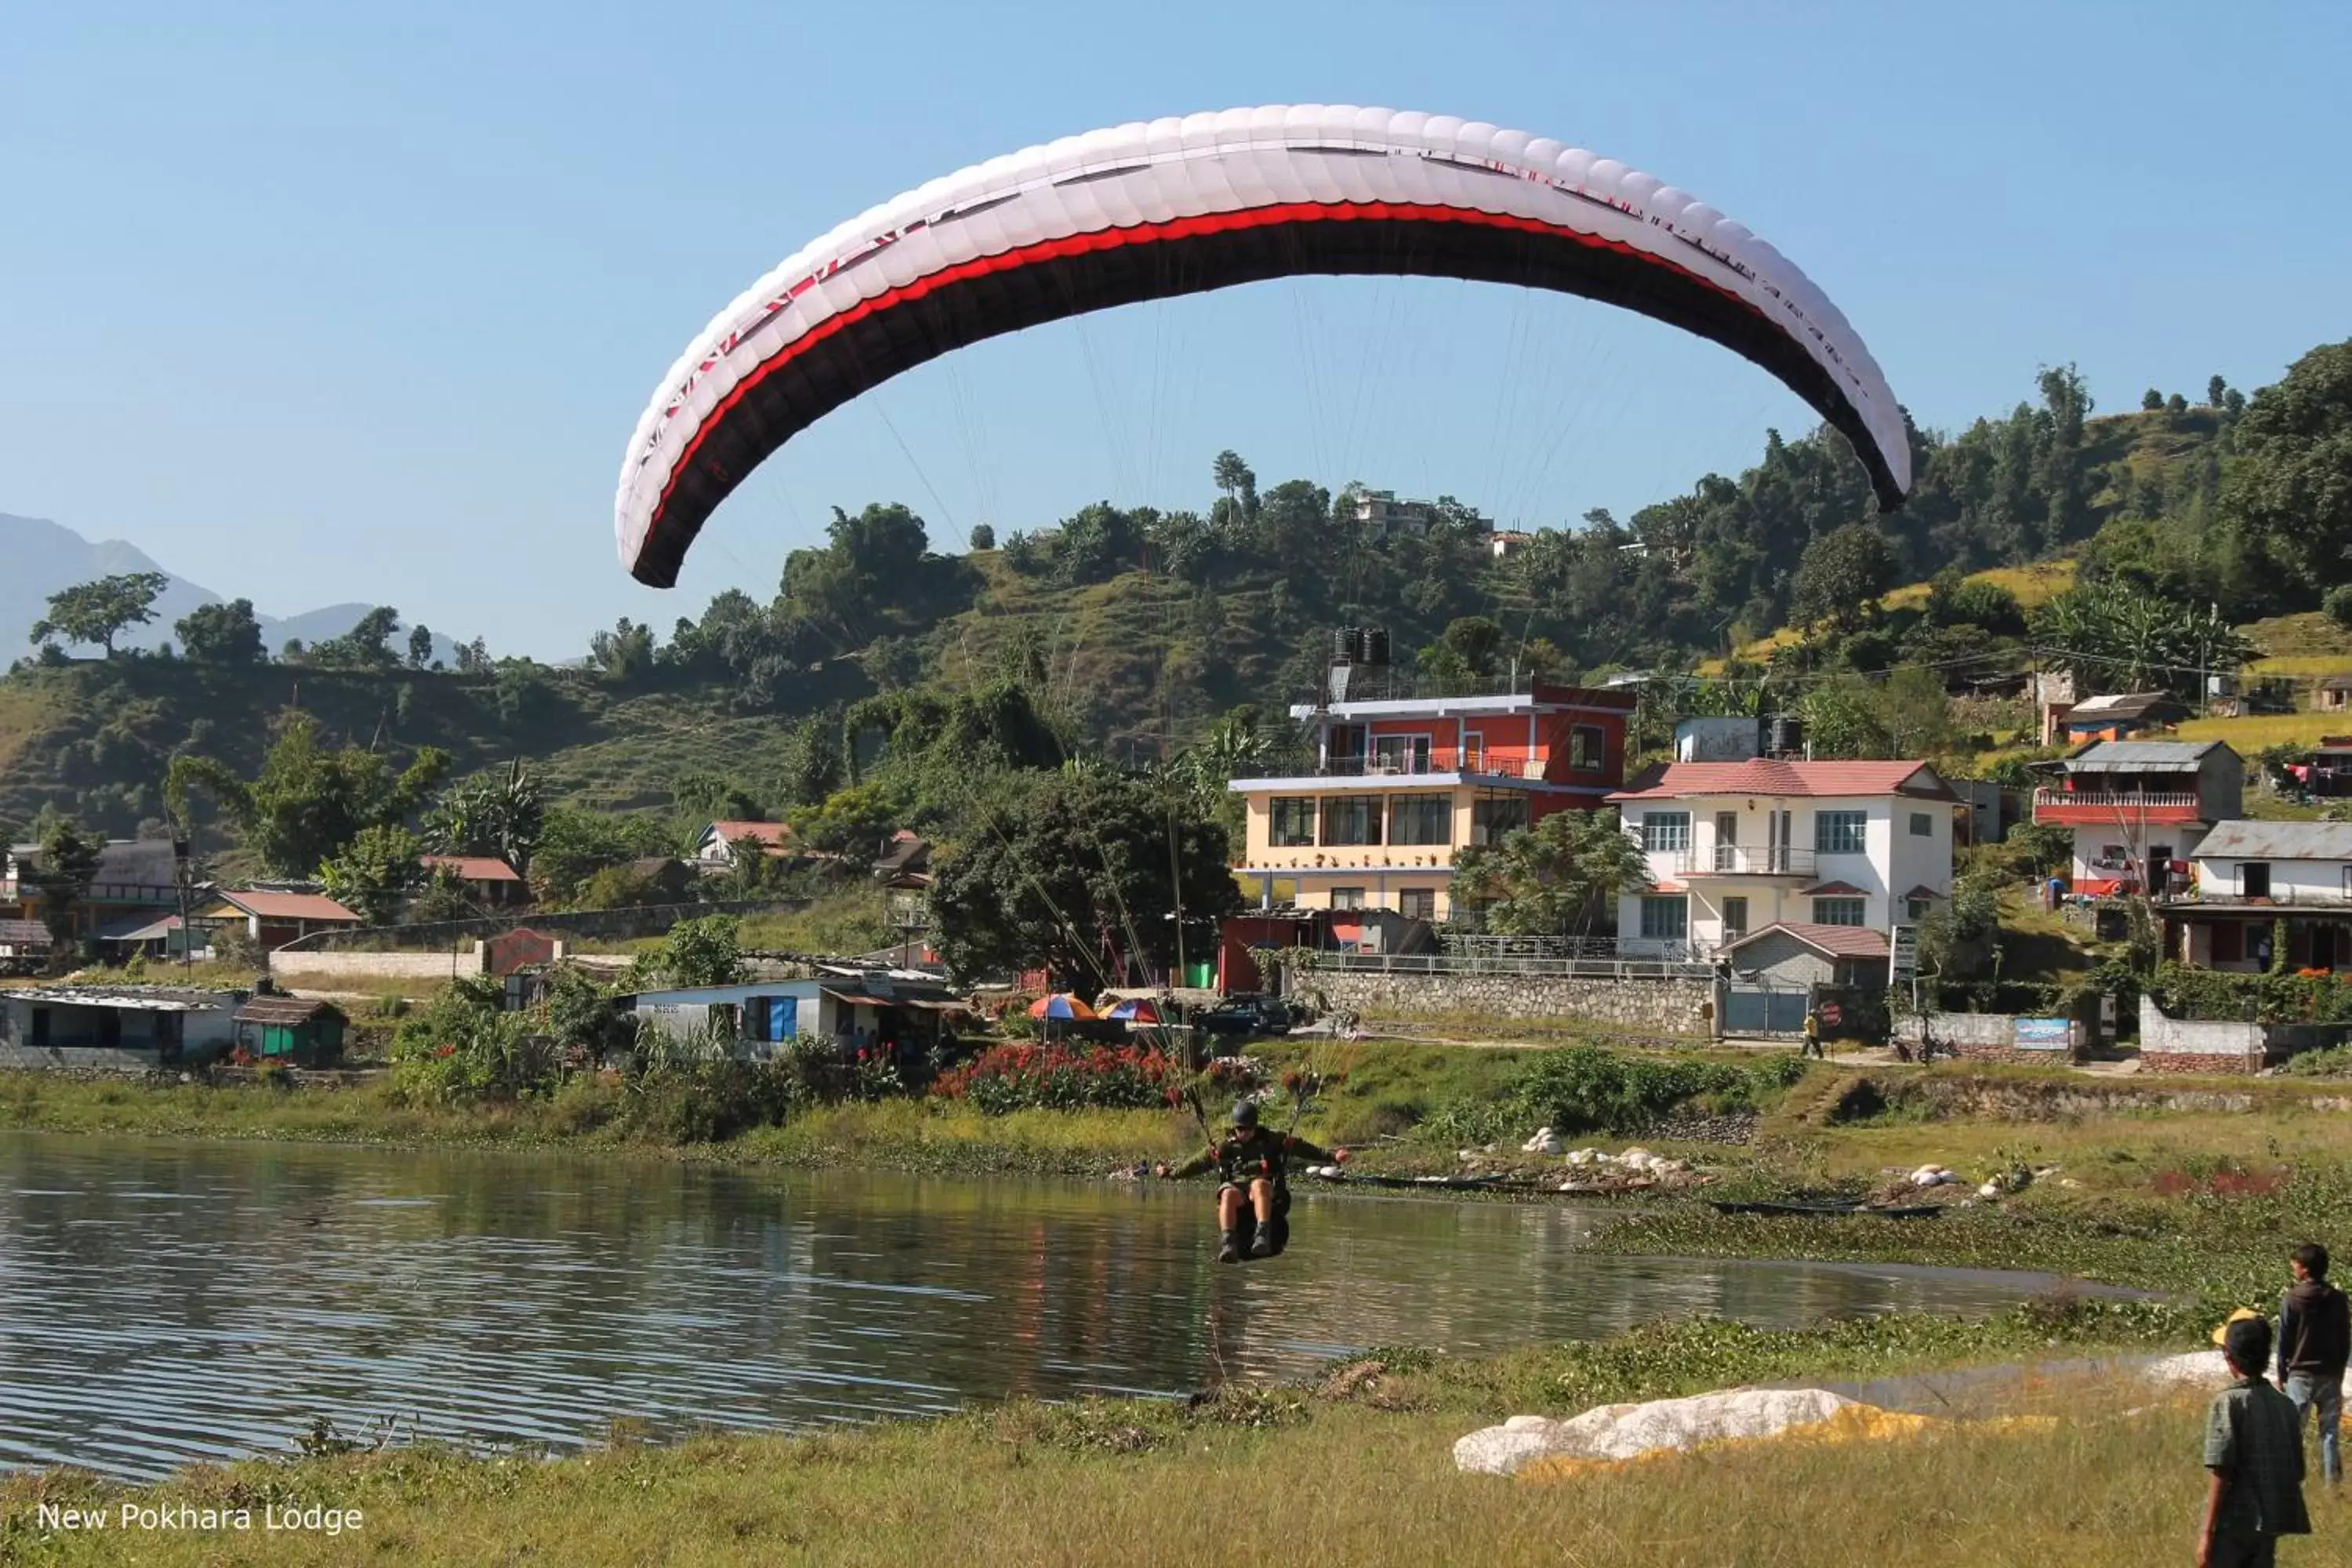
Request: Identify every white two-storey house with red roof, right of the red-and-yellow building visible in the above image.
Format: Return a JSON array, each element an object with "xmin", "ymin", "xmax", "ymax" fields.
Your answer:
[{"xmin": 1609, "ymin": 757, "xmax": 1957, "ymax": 968}]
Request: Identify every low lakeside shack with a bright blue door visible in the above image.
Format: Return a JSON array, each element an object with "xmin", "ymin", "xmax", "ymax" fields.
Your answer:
[{"xmin": 614, "ymin": 968, "xmax": 969, "ymax": 1060}]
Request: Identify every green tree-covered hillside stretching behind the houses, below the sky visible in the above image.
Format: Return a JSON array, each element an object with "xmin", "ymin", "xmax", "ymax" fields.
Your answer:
[{"xmin": 0, "ymin": 346, "xmax": 2352, "ymax": 921}]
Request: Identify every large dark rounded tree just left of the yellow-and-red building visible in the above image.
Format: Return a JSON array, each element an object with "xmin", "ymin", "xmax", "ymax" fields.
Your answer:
[{"xmin": 931, "ymin": 769, "xmax": 1240, "ymax": 980}]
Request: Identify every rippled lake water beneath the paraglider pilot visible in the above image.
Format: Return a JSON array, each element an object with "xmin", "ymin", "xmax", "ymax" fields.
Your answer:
[{"xmin": 0, "ymin": 1133, "xmax": 2126, "ymax": 1476}]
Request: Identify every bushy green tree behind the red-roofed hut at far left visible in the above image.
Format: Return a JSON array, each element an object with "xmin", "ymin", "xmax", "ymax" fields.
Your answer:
[{"xmin": 165, "ymin": 713, "xmax": 449, "ymax": 877}]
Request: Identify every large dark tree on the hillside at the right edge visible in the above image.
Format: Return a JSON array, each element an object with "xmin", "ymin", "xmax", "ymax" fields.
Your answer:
[{"xmin": 2220, "ymin": 341, "xmax": 2352, "ymax": 604}]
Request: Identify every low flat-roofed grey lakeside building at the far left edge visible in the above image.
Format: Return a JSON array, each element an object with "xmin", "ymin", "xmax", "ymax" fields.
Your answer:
[{"xmin": 0, "ymin": 985, "xmax": 242, "ymax": 1072}]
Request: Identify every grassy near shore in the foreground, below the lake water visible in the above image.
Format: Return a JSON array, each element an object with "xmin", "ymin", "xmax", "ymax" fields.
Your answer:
[{"xmin": 0, "ymin": 1302, "xmax": 2277, "ymax": 1568}]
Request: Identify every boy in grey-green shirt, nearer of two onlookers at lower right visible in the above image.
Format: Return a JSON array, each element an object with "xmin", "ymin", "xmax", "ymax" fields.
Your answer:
[{"xmin": 2197, "ymin": 1307, "xmax": 2312, "ymax": 1568}]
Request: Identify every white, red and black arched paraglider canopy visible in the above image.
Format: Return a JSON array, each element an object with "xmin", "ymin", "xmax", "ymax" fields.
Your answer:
[{"xmin": 614, "ymin": 103, "xmax": 1912, "ymax": 588}]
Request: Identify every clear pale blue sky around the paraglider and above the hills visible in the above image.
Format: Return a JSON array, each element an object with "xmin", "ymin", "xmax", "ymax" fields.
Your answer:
[{"xmin": 0, "ymin": 0, "xmax": 2352, "ymax": 659}]
